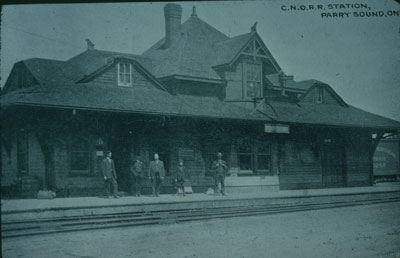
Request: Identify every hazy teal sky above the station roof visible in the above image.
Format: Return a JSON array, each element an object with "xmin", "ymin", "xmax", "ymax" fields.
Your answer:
[{"xmin": 0, "ymin": 0, "xmax": 400, "ymax": 120}]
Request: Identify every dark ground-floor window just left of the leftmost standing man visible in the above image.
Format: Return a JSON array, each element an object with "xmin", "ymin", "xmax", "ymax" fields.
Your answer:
[{"xmin": 70, "ymin": 138, "xmax": 90, "ymax": 174}]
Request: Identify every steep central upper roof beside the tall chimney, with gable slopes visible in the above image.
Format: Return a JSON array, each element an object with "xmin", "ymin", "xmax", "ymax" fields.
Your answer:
[{"xmin": 142, "ymin": 16, "xmax": 280, "ymax": 80}]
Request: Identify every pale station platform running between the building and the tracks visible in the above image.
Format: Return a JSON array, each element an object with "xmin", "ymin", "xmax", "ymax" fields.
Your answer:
[{"xmin": 1, "ymin": 183, "xmax": 400, "ymax": 222}]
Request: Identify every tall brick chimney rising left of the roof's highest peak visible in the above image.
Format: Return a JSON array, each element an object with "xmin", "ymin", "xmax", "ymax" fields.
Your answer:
[{"xmin": 164, "ymin": 4, "xmax": 182, "ymax": 48}]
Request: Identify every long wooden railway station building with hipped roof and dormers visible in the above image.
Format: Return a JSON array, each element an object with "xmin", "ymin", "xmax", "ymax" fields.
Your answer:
[{"xmin": 1, "ymin": 4, "xmax": 400, "ymax": 197}]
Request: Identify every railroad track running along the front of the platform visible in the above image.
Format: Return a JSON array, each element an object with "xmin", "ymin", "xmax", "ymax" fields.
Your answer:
[{"xmin": 1, "ymin": 197, "xmax": 400, "ymax": 238}]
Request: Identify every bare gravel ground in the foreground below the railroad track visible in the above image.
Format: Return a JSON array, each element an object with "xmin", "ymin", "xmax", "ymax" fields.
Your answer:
[{"xmin": 2, "ymin": 203, "xmax": 400, "ymax": 258}]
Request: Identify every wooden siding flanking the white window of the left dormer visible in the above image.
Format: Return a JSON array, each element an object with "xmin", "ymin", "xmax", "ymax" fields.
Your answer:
[{"xmin": 92, "ymin": 64, "xmax": 155, "ymax": 87}]
